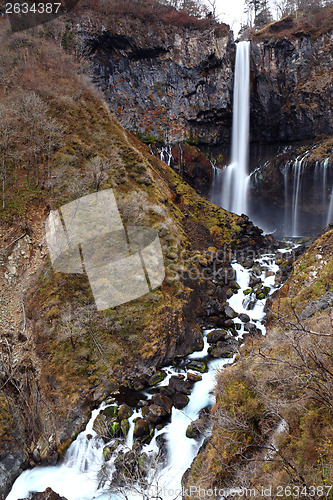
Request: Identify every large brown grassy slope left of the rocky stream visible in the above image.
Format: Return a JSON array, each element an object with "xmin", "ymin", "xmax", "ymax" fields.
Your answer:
[{"xmin": 0, "ymin": 19, "xmax": 265, "ymax": 498}]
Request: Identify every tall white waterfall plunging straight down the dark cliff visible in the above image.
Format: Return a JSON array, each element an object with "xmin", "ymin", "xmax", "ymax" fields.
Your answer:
[{"xmin": 212, "ymin": 42, "xmax": 250, "ymax": 215}]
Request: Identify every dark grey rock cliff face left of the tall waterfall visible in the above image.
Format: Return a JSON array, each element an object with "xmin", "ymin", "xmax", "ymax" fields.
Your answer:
[{"xmin": 76, "ymin": 17, "xmax": 234, "ymax": 143}]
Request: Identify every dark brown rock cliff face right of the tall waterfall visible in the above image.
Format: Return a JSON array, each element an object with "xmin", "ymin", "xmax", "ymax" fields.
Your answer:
[{"xmin": 251, "ymin": 19, "xmax": 333, "ymax": 142}]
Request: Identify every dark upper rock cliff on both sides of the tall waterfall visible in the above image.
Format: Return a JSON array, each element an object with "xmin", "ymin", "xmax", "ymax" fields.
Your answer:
[{"xmin": 70, "ymin": 11, "xmax": 333, "ymax": 148}]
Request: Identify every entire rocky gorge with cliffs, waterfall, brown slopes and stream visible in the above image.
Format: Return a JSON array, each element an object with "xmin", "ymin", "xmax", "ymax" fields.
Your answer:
[{"xmin": 0, "ymin": 0, "xmax": 333, "ymax": 500}]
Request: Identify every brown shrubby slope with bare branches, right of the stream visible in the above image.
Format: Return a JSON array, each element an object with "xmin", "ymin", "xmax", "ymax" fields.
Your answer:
[{"xmin": 186, "ymin": 228, "xmax": 333, "ymax": 498}]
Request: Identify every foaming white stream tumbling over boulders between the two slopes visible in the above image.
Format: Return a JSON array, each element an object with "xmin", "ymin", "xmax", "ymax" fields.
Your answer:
[{"xmin": 7, "ymin": 250, "xmax": 278, "ymax": 500}]
